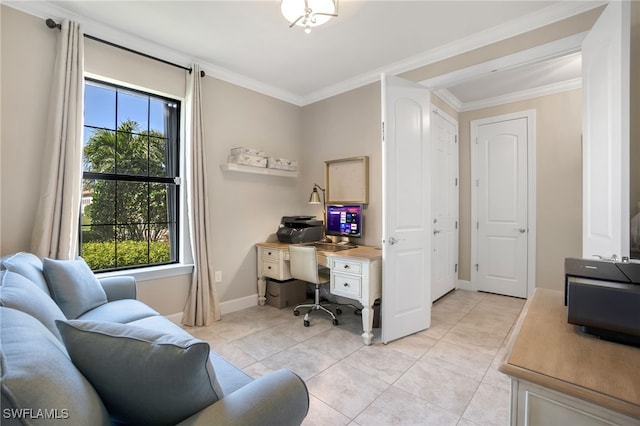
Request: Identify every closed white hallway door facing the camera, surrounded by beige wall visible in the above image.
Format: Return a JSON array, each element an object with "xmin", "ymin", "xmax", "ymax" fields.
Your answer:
[{"xmin": 471, "ymin": 115, "xmax": 529, "ymax": 297}]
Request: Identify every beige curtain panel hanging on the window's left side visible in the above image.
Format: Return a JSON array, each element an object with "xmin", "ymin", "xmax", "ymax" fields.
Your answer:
[{"xmin": 31, "ymin": 20, "xmax": 84, "ymax": 259}]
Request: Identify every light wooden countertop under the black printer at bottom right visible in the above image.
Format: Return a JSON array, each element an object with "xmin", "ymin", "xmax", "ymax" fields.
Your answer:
[{"xmin": 499, "ymin": 288, "xmax": 640, "ymax": 418}]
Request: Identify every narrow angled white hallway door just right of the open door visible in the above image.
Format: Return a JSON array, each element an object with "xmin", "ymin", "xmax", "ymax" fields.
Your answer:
[{"xmin": 431, "ymin": 109, "xmax": 458, "ymax": 301}]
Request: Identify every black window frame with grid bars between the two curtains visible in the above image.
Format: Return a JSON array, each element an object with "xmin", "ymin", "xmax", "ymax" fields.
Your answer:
[{"xmin": 78, "ymin": 75, "xmax": 186, "ymax": 276}]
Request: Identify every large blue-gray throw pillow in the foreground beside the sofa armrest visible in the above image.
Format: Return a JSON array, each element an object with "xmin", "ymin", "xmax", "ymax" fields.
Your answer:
[{"xmin": 57, "ymin": 320, "xmax": 220, "ymax": 425}]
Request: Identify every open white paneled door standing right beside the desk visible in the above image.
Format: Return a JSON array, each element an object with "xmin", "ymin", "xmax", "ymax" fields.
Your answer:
[{"xmin": 381, "ymin": 75, "xmax": 431, "ymax": 343}]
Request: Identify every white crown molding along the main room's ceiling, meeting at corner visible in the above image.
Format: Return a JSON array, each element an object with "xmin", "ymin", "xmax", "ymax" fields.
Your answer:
[{"xmin": 3, "ymin": 0, "xmax": 607, "ymax": 106}]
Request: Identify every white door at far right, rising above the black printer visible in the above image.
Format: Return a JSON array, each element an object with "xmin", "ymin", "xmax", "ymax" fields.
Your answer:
[{"xmin": 582, "ymin": 1, "xmax": 631, "ymax": 258}]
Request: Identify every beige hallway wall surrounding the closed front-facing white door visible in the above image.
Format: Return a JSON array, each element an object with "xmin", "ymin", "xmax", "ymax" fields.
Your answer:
[{"xmin": 459, "ymin": 90, "xmax": 582, "ymax": 290}]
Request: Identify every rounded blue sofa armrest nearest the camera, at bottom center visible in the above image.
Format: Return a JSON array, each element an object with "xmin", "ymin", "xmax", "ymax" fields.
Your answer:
[{"xmin": 179, "ymin": 370, "xmax": 309, "ymax": 426}]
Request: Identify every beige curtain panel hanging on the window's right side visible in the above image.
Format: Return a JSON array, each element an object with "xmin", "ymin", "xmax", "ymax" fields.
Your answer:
[{"xmin": 182, "ymin": 64, "xmax": 220, "ymax": 326}]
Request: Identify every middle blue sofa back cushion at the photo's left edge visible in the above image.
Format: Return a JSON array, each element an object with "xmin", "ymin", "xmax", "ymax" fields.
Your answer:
[{"xmin": 0, "ymin": 271, "xmax": 66, "ymax": 342}]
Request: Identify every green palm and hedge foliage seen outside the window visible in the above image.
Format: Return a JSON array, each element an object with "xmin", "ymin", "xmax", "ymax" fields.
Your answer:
[{"xmin": 81, "ymin": 120, "xmax": 175, "ymax": 270}]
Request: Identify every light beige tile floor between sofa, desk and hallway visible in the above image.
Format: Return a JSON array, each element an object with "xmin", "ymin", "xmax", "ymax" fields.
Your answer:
[{"xmin": 187, "ymin": 290, "xmax": 525, "ymax": 426}]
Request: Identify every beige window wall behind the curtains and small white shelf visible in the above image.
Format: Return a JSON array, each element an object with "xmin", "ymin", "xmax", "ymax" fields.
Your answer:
[{"xmin": 0, "ymin": 6, "xmax": 302, "ymax": 314}]
